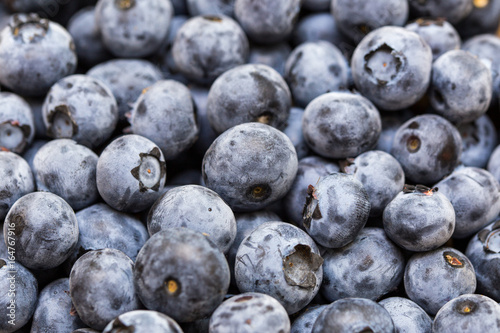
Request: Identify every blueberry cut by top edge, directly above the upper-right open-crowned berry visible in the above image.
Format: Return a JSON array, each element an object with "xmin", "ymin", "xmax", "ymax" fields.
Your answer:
[{"xmin": 330, "ymin": 0, "xmax": 408, "ymax": 43}]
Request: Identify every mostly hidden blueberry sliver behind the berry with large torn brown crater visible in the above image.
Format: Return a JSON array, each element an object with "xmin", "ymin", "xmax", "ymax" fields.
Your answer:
[{"xmin": 227, "ymin": 210, "xmax": 281, "ymax": 286}]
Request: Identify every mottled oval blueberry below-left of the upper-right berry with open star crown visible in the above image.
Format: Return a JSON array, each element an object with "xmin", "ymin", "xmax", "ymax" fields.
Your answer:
[{"xmin": 302, "ymin": 92, "xmax": 382, "ymax": 158}]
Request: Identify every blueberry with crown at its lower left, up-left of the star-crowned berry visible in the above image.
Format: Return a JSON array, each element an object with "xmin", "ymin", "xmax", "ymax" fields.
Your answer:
[{"xmin": 42, "ymin": 75, "xmax": 118, "ymax": 148}]
